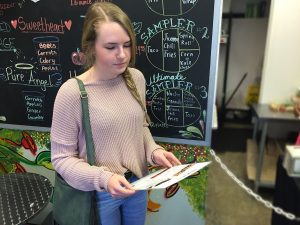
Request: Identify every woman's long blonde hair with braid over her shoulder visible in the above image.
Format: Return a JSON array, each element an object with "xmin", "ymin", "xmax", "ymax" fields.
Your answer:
[{"xmin": 81, "ymin": 2, "xmax": 150, "ymax": 123}]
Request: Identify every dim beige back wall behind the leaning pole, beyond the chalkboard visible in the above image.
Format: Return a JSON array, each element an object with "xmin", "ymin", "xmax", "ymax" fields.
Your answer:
[{"xmin": 226, "ymin": 18, "xmax": 268, "ymax": 109}]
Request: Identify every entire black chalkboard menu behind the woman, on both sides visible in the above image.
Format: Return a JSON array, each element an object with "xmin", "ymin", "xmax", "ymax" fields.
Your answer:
[{"xmin": 0, "ymin": 0, "xmax": 221, "ymax": 145}]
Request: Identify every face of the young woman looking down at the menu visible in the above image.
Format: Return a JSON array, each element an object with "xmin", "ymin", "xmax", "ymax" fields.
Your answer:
[{"xmin": 95, "ymin": 22, "xmax": 131, "ymax": 79}]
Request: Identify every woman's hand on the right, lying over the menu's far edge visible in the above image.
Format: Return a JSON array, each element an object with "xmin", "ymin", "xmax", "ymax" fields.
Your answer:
[{"xmin": 152, "ymin": 148, "xmax": 181, "ymax": 168}]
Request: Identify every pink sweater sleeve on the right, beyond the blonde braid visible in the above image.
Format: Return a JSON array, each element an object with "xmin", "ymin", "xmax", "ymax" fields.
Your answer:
[{"xmin": 134, "ymin": 69, "xmax": 164, "ymax": 165}]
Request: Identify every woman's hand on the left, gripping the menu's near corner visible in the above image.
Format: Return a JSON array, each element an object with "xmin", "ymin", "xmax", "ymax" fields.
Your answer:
[{"xmin": 107, "ymin": 174, "xmax": 135, "ymax": 198}]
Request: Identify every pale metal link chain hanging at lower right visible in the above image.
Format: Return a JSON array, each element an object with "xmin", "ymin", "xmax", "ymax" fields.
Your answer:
[{"xmin": 209, "ymin": 149, "xmax": 300, "ymax": 221}]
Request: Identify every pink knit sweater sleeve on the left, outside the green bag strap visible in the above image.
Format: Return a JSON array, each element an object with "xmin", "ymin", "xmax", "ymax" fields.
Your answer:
[{"xmin": 51, "ymin": 79, "xmax": 113, "ymax": 191}]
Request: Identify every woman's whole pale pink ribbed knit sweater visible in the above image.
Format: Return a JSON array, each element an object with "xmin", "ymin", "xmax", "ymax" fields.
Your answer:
[{"xmin": 51, "ymin": 68, "xmax": 160, "ymax": 191}]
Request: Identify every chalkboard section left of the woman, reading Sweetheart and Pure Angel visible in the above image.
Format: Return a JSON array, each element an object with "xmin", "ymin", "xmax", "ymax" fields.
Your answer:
[{"xmin": 0, "ymin": 0, "xmax": 88, "ymax": 130}]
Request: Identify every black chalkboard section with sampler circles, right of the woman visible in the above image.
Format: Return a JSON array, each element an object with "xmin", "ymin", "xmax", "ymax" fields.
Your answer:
[{"xmin": 113, "ymin": 0, "xmax": 221, "ymax": 145}]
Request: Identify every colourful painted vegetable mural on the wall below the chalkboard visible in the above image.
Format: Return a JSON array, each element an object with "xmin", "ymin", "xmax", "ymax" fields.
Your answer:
[{"xmin": 0, "ymin": 128, "xmax": 210, "ymax": 224}]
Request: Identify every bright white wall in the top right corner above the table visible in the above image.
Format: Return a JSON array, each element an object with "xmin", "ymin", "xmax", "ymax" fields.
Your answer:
[{"xmin": 259, "ymin": 0, "xmax": 300, "ymax": 103}]
